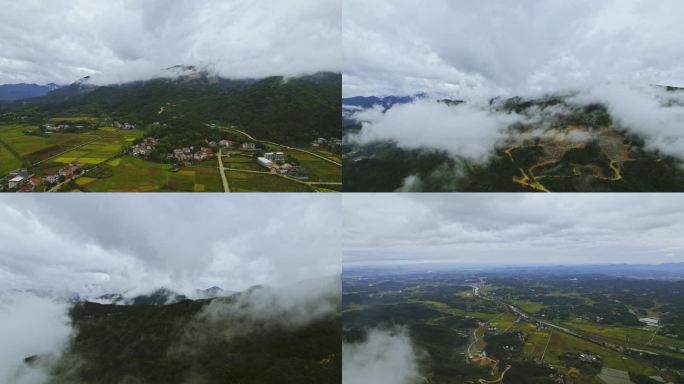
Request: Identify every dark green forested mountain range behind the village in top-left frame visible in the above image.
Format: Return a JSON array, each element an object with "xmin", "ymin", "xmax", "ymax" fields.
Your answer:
[{"xmin": 0, "ymin": 70, "xmax": 342, "ymax": 144}]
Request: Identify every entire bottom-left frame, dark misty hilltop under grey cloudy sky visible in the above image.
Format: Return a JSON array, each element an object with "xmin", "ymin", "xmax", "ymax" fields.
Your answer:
[{"xmin": 0, "ymin": 195, "xmax": 341, "ymax": 384}]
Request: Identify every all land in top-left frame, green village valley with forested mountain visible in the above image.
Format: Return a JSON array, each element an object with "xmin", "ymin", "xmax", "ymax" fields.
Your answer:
[{"xmin": 0, "ymin": 74, "xmax": 342, "ymax": 192}]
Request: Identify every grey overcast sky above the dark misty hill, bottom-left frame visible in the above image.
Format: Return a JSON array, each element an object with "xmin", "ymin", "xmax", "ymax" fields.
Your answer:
[{"xmin": 0, "ymin": 194, "xmax": 341, "ymax": 295}]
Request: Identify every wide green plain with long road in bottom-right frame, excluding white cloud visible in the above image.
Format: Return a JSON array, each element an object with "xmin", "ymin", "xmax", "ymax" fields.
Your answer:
[{"xmin": 343, "ymin": 271, "xmax": 684, "ymax": 384}]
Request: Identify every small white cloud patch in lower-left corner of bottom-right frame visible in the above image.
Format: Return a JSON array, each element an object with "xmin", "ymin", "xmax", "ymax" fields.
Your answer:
[{"xmin": 342, "ymin": 328, "xmax": 422, "ymax": 384}]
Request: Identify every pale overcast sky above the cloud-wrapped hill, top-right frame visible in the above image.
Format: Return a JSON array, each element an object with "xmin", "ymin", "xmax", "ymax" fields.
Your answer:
[{"xmin": 342, "ymin": 0, "xmax": 684, "ymax": 97}]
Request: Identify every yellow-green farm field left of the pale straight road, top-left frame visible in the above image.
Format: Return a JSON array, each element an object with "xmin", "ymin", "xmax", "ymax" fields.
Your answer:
[{"xmin": 77, "ymin": 156, "xmax": 223, "ymax": 192}]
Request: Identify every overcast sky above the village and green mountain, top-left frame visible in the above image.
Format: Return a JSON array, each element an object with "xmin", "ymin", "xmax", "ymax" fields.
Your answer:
[{"xmin": 0, "ymin": 0, "xmax": 342, "ymax": 84}]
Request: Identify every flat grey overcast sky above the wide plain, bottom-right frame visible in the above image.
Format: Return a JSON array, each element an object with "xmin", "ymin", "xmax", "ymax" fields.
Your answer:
[{"xmin": 343, "ymin": 193, "xmax": 684, "ymax": 266}]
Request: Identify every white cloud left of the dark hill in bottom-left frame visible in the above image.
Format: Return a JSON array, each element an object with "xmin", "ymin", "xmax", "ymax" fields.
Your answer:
[{"xmin": 0, "ymin": 292, "xmax": 71, "ymax": 384}]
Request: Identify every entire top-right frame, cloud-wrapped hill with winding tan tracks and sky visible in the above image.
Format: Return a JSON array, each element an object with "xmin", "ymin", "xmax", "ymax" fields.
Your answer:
[{"xmin": 343, "ymin": 0, "xmax": 684, "ymax": 192}]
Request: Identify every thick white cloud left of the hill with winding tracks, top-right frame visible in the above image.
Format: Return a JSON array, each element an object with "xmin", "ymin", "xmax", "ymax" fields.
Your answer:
[{"xmin": 349, "ymin": 100, "xmax": 521, "ymax": 160}]
